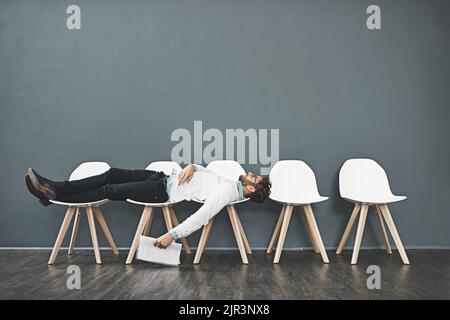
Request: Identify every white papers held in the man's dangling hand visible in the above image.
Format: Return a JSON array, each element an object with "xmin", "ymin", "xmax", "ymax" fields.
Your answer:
[{"xmin": 136, "ymin": 236, "xmax": 181, "ymax": 266}]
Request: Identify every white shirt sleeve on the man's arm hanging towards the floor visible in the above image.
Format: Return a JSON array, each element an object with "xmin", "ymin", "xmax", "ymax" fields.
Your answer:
[{"xmin": 170, "ymin": 188, "xmax": 236, "ymax": 239}]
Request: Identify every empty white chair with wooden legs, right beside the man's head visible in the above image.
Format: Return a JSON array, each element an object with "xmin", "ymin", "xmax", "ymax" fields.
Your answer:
[{"xmin": 267, "ymin": 160, "xmax": 329, "ymax": 263}]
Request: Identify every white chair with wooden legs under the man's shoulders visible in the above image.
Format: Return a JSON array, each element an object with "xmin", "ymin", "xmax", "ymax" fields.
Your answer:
[{"xmin": 194, "ymin": 160, "xmax": 252, "ymax": 264}]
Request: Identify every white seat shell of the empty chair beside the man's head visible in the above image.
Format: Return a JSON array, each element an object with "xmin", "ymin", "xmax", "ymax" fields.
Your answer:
[{"xmin": 269, "ymin": 160, "xmax": 321, "ymax": 202}]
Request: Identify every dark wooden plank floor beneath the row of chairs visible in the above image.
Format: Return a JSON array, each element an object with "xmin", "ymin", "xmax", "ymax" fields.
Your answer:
[{"xmin": 0, "ymin": 250, "xmax": 450, "ymax": 299}]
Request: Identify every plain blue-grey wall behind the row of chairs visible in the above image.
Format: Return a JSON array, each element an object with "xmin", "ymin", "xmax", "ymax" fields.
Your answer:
[{"xmin": 0, "ymin": 0, "xmax": 450, "ymax": 247}]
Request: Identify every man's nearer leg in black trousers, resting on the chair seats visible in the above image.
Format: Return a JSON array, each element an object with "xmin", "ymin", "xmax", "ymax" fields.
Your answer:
[{"xmin": 56, "ymin": 173, "xmax": 169, "ymax": 203}]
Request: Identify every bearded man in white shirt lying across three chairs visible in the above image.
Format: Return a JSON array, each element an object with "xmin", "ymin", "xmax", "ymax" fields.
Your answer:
[{"xmin": 25, "ymin": 164, "xmax": 271, "ymax": 248}]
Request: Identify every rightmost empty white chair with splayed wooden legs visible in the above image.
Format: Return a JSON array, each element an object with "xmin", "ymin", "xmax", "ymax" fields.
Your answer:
[{"xmin": 336, "ymin": 159, "xmax": 409, "ymax": 264}]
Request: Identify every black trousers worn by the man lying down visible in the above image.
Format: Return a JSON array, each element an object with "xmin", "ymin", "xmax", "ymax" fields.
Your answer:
[{"xmin": 51, "ymin": 168, "xmax": 169, "ymax": 203}]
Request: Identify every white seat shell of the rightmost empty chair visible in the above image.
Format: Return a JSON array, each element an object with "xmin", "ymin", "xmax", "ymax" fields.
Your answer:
[{"xmin": 339, "ymin": 159, "xmax": 393, "ymax": 200}]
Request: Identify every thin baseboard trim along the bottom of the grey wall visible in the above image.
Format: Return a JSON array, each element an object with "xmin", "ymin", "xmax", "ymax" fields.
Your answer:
[{"xmin": 0, "ymin": 246, "xmax": 450, "ymax": 251}]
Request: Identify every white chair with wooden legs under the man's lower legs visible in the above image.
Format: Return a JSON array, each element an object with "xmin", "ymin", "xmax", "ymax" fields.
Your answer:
[{"xmin": 48, "ymin": 162, "xmax": 119, "ymax": 264}]
